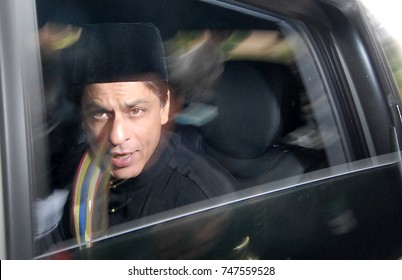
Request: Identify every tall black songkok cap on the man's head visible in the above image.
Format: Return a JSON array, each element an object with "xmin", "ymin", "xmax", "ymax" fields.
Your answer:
[{"xmin": 62, "ymin": 23, "xmax": 168, "ymax": 85}]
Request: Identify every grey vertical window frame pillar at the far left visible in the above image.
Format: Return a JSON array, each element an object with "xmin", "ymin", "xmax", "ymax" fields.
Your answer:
[{"xmin": 0, "ymin": 0, "xmax": 46, "ymax": 259}]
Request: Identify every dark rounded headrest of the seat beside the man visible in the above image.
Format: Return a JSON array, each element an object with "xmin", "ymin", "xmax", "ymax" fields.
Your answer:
[{"xmin": 202, "ymin": 61, "xmax": 283, "ymax": 159}]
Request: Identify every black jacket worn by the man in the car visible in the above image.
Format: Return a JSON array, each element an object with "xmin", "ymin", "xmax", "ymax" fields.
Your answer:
[{"xmin": 60, "ymin": 132, "xmax": 237, "ymax": 239}]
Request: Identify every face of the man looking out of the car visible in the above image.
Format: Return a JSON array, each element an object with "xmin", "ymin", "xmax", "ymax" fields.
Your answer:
[{"xmin": 81, "ymin": 82, "xmax": 169, "ymax": 179}]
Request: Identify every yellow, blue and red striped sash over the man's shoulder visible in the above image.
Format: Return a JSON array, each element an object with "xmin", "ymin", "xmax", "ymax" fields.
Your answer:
[{"xmin": 72, "ymin": 151, "xmax": 110, "ymax": 247}]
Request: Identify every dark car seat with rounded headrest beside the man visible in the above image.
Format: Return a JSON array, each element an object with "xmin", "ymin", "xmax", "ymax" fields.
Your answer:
[{"xmin": 177, "ymin": 61, "xmax": 322, "ymax": 187}]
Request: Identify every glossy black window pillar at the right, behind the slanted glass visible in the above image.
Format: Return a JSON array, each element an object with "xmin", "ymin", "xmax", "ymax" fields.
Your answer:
[{"xmin": 313, "ymin": 1, "xmax": 401, "ymax": 158}]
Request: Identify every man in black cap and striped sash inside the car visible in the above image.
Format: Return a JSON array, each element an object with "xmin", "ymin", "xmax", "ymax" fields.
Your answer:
[{"xmin": 54, "ymin": 24, "xmax": 235, "ymax": 243}]
